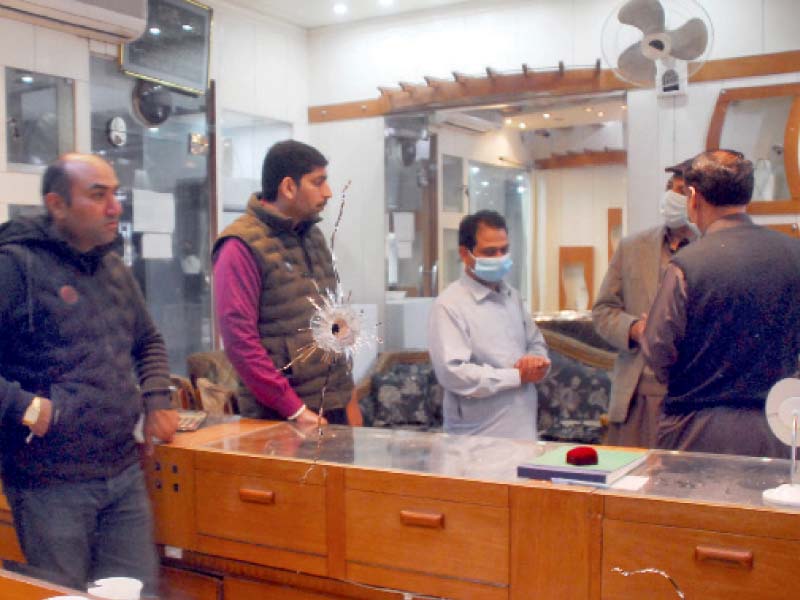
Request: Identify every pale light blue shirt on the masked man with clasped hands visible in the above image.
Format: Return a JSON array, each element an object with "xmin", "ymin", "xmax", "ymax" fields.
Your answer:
[{"xmin": 428, "ymin": 273, "xmax": 547, "ymax": 440}]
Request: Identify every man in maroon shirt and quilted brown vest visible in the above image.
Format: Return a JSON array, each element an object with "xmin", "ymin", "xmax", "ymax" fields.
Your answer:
[{"xmin": 214, "ymin": 140, "xmax": 353, "ymax": 423}]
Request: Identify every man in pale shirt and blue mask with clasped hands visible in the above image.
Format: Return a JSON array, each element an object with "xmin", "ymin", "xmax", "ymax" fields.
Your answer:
[{"xmin": 428, "ymin": 210, "xmax": 550, "ymax": 440}]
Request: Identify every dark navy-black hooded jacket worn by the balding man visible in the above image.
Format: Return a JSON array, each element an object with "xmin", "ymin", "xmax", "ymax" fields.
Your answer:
[{"xmin": 0, "ymin": 217, "xmax": 169, "ymax": 487}]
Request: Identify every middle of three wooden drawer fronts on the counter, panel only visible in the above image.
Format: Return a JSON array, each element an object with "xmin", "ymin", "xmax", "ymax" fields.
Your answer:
[{"xmin": 345, "ymin": 490, "xmax": 509, "ymax": 585}]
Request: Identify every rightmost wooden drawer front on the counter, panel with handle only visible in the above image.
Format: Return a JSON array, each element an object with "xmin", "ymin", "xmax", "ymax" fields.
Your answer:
[{"xmin": 602, "ymin": 519, "xmax": 800, "ymax": 600}]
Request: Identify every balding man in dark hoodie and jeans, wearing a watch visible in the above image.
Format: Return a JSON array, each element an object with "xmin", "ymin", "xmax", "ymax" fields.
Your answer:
[{"xmin": 0, "ymin": 154, "xmax": 177, "ymax": 595}]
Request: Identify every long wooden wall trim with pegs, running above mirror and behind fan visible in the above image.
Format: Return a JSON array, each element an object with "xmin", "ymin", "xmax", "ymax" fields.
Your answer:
[{"xmin": 308, "ymin": 50, "xmax": 800, "ymax": 123}]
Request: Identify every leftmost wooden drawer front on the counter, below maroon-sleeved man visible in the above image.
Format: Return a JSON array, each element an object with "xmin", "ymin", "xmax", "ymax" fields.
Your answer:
[{"xmin": 196, "ymin": 471, "xmax": 326, "ymax": 555}]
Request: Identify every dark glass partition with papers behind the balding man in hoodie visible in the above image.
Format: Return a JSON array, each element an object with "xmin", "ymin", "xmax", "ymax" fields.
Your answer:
[{"xmin": 91, "ymin": 57, "xmax": 213, "ymax": 374}]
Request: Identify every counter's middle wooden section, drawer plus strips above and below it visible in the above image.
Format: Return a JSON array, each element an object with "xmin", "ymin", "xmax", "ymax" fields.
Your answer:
[{"xmin": 345, "ymin": 471, "xmax": 509, "ymax": 598}]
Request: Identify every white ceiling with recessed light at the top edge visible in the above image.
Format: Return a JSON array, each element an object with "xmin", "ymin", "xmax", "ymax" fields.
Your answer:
[{"xmin": 220, "ymin": 0, "xmax": 476, "ymax": 29}]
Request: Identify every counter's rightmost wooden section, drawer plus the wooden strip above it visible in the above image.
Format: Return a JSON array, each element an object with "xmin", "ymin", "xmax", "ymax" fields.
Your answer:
[{"xmin": 601, "ymin": 497, "xmax": 800, "ymax": 600}]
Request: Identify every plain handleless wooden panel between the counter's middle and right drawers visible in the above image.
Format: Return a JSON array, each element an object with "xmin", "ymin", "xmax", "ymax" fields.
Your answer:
[{"xmin": 510, "ymin": 485, "xmax": 601, "ymax": 600}]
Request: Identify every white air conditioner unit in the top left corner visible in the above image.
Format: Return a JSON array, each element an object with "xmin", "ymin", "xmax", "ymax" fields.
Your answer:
[{"xmin": 0, "ymin": 0, "xmax": 147, "ymax": 44}]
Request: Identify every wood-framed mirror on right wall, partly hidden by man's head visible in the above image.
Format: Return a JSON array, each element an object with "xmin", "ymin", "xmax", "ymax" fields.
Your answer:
[{"xmin": 706, "ymin": 84, "xmax": 800, "ymax": 214}]
